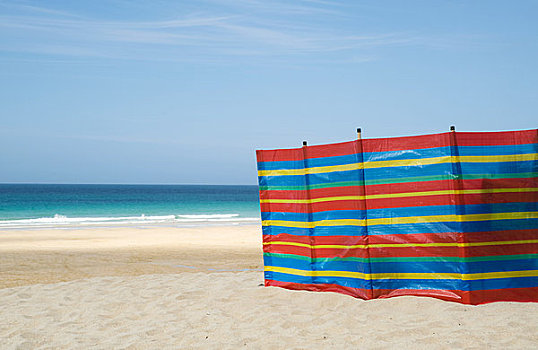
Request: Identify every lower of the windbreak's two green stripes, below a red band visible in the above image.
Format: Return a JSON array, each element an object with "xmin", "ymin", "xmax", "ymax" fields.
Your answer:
[{"xmin": 263, "ymin": 253, "xmax": 538, "ymax": 263}]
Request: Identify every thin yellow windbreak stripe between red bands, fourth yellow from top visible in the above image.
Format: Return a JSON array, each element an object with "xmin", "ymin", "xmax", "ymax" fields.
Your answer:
[{"xmin": 263, "ymin": 239, "xmax": 538, "ymax": 249}]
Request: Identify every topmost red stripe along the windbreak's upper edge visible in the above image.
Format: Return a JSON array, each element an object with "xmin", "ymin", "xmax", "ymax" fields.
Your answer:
[{"xmin": 256, "ymin": 129, "xmax": 538, "ymax": 162}]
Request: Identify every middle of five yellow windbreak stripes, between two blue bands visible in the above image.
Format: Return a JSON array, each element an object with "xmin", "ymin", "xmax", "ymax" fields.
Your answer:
[{"xmin": 262, "ymin": 211, "xmax": 538, "ymax": 228}]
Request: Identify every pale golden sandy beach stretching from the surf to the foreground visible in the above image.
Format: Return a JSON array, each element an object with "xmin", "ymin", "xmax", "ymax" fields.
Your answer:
[{"xmin": 0, "ymin": 226, "xmax": 538, "ymax": 349}]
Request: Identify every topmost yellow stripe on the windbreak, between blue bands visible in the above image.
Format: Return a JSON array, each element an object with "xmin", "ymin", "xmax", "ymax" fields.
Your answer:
[{"xmin": 258, "ymin": 153, "xmax": 538, "ymax": 176}]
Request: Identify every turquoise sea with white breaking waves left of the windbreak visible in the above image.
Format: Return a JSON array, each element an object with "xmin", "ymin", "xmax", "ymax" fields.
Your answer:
[{"xmin": 0, "ymin": 184, "xmax": 260, "ymax": 229}]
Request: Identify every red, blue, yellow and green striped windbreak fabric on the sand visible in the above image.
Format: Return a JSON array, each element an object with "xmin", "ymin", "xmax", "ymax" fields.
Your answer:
[{"xmin": 257, "ymin": 129, "xmax": 538, "ymax": 304}]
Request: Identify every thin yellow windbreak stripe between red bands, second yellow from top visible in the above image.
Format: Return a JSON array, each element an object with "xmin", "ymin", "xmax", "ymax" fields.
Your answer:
[{"xmin": 260, "ymin": 187, "xmax": 538, "ymax": 204}]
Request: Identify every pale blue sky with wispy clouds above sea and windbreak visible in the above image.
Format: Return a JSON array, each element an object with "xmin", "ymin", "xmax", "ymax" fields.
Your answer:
[{"xmin": 0, "ymin": 0, "xmax": 538, "ymax": 184}]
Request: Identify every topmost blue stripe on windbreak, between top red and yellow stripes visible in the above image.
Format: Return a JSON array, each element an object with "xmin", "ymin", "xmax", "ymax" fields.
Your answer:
[{"xmin": 258, "ymin": 144, "xmax": 538, "ymax": 170}]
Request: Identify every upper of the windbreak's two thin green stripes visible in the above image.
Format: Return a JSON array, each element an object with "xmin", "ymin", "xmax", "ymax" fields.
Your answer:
[{"xmin": 260, "ymin": 172, "xmax": 538, "ymax": 191}]
